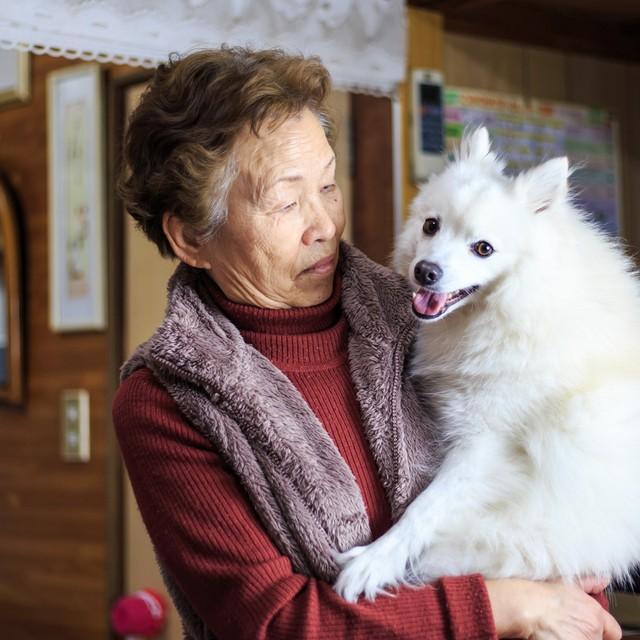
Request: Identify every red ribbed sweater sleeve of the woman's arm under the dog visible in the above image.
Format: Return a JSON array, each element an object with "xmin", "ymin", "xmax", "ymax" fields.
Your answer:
[{"xmin": 113, "ymin": 369, "xmax": 496, "ymax": 640}]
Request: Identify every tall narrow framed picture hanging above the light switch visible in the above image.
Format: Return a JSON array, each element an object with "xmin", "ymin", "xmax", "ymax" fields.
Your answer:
[{"xmin": 47, "ymin": 64, "xmax": 106, "ymax": 331}]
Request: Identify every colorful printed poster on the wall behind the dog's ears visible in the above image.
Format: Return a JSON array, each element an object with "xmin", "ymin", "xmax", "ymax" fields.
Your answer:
[{"xmin": 445, "ymin": 87, "xmax": 621, "ymax": 235}]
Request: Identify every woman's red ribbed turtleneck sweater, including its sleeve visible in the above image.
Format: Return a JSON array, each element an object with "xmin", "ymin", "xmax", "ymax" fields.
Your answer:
[{"xmin": 114, "ymin": 276, "xmax": 495, "ymax": 640}]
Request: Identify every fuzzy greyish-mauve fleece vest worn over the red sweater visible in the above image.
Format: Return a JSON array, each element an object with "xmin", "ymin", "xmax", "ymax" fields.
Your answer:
[{"xmin": 121, "ymin": 243, "xmax": 434, "ymax": 637}]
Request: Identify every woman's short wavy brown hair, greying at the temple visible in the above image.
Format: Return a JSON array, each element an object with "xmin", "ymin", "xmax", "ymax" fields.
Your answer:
[{"xmin": 118, "ymin": 47, "xmax": 335, "ymax": 257}]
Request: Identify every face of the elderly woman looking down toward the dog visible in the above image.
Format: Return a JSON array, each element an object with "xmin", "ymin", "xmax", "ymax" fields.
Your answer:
[{"xmin": 201, "ymin": 109, "xmax": 344, "ymax": 309}]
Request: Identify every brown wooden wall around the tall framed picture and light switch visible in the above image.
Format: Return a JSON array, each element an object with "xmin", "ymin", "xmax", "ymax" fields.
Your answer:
[{"xmin": 0, "ymin": 56, "xmax": 133, "ymax": 640}]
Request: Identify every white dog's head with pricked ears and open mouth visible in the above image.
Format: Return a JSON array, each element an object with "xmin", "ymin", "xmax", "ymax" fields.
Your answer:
[{"xmin": 395, "ymin": 129, "xmax": 568, "ymax": 322}]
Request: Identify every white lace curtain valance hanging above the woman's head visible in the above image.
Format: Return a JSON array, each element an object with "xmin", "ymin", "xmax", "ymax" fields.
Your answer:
[{"xmin": 0, "ymin": 0, "xmax": 405, "ymax": 95}]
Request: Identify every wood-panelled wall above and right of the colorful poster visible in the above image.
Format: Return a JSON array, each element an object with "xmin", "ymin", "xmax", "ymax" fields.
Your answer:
[{"xmin": 444, "ymin": 33, "xmax": 640, "ymax": 251}]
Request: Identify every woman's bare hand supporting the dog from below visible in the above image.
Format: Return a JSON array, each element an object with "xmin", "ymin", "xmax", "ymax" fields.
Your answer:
[{"xmin": 486, "ymin": 580, "xmax": 622, "ymax": 640}]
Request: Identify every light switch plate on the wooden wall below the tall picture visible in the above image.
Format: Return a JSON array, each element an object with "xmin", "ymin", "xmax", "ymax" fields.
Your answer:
[{"xmin": 60, "ymin": 389, "xmax": 91, "ymax": 462}]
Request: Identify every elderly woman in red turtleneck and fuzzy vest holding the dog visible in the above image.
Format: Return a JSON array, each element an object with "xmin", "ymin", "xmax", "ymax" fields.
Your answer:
[{"xmin": 114, "ymin": 48, "xmax": 618, "ymax": 640}]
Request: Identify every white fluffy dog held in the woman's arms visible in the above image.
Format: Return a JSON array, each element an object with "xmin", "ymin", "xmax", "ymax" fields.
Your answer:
[{"xmin": 335, "ymin": 128, "xmax": 640, "ymax": 600}]
